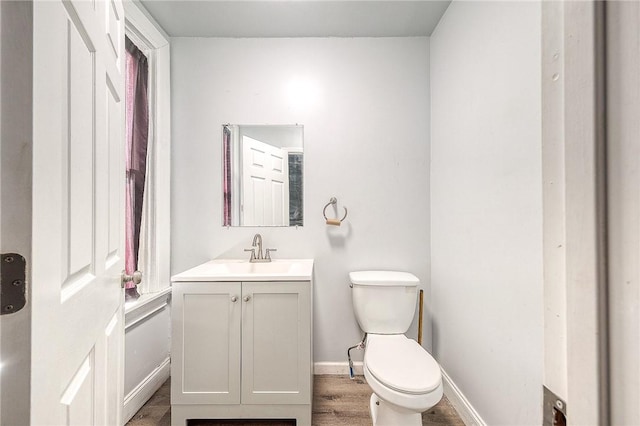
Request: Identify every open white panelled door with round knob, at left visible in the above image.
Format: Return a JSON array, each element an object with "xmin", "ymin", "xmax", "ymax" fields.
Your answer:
[{"xmin": 31, "ymin": 0, "xmax": 125, "ymax": 426}]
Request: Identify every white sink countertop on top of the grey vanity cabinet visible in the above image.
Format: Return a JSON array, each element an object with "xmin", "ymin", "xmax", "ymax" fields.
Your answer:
[{"xmin": 171, "ymin": 259, "xmax": 313, "ymax": 281}]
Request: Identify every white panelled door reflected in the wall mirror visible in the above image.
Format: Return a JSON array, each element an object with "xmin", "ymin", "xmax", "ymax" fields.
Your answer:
[{"xmin": 242, "ymin": 136, "xmax": 289, "ymax": 226}]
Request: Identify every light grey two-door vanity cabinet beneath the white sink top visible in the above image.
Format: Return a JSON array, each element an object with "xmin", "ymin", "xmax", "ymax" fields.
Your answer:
[{"xmin": 171, "ymin": 264, "xmax": 313, "ymax": 426}]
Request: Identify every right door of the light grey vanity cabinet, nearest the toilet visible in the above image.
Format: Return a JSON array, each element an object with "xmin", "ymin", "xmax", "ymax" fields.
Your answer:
[{"xmin": 242, "ymin": 282, "xmax": 311, "ymax": 404}]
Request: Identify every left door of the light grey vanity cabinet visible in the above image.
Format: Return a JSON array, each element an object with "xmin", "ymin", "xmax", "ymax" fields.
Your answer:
[{"xmin": 171, "ymin": 282, "xmax": 241, "ymax": 404}]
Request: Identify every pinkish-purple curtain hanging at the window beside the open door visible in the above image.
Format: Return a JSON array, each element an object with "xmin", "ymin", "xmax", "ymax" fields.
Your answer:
[{"xmin": 125, "ymin": 38, "xmax": 149, "ymax": 297}]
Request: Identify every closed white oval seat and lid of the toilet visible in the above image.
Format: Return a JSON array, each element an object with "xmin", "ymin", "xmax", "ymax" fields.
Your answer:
[{"xmin": 364, "ymin": 334, "xmax": 442, "ymax": 395}]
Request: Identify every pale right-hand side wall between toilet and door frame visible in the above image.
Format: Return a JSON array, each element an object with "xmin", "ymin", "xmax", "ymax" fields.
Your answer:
[{"xmin": 431, "ymin": 2, "xmax": 543, "ymax": 425}]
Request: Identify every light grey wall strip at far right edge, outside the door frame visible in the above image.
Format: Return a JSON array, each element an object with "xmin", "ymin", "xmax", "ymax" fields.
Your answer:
[{"xmin": 604, "ymin": 2, "xmax": 640, "ymax": 425}]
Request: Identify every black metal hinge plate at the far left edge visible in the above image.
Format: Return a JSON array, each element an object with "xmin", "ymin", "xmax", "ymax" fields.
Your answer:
[{"xmin": 0, "ymin": 253, "xmax": 27, "ymax": 315}]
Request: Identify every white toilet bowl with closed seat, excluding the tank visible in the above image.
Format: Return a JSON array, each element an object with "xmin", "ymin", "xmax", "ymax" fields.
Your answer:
[{"xmin": 363, "ymin": 334, "xmax": 442, "ymax": 426}]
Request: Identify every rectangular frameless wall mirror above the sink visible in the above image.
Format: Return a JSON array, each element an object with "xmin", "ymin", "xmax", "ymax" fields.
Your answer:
[{"xmin": 222, "ymin": 124, "xmax": 304, "ymax": 226}]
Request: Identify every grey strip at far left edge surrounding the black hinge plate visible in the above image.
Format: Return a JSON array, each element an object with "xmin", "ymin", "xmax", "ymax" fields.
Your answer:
[{"xmin": 0, "ymin": 1, "xmax": 33, "ymax": 425}]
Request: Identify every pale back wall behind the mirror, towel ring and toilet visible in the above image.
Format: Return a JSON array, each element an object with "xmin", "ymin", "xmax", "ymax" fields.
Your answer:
[{"xmin": 171, "ymin": 37, "xmax": 431, "ymax": 362}]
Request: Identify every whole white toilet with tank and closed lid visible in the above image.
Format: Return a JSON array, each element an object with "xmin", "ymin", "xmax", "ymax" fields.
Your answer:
[{"xmin": 349, "ymin": 271, "xmax": 442, "ymax": 426}]
